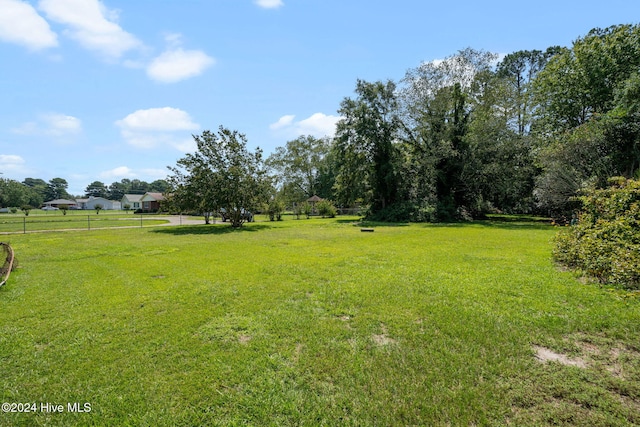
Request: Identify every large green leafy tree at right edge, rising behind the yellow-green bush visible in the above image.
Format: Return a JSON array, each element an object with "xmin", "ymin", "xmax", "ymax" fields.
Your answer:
[{"xmin": 534, "ymin": 25, "xmax": 640, "ymax": 216}]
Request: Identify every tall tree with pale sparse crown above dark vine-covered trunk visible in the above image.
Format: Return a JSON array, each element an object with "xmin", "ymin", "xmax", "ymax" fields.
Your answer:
[{"xmin": 401, "ymin": 49, "xmax": 497, "ymax": 220}]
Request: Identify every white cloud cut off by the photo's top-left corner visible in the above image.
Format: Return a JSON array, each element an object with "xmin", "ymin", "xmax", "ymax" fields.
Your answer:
[{"xmin": 0, "ymin": 0, "xmax": 58, "ymax": 50}]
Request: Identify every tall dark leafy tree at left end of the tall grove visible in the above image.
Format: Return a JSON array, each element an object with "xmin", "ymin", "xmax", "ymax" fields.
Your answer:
[{"xmin": 335, "ymin": 80, "xmax": 401, "ymax": 212}]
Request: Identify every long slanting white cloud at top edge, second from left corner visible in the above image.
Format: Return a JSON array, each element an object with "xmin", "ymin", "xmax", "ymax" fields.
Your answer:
[{"xmin": 38, "ymin": 0, "xmax": 142, "ymax": 59}]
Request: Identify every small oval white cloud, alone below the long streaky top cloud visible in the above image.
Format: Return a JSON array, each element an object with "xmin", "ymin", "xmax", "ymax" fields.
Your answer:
[{"xmin": 147, "ymin": 48, "xmax": 215, "ymax": 83}]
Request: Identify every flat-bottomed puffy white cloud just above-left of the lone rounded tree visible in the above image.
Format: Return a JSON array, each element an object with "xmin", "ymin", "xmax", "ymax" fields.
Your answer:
[{"xmin": 115, "ymin": 107, "xmax": 200, "ymax": 151}]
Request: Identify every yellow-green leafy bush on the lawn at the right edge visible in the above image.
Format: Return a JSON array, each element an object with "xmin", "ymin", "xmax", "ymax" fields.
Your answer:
[{"xmin": 553, "ymin": 178, "xmax": 640, "ymax": 289}]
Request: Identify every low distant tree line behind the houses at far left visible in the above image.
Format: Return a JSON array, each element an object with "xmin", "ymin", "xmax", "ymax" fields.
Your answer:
[{"xmin": 0, "ymin": 178, "xmax": 168, "ymax": 208}]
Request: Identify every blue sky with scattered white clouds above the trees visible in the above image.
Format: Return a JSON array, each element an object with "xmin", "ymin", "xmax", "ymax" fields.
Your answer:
[{"xmin": 0, "ymin": 0, "xmax": 640, "ymax": 195}]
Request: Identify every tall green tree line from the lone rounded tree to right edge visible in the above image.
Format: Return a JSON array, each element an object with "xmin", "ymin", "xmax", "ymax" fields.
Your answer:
[{"xmin": 168, "ymin": 25, "xmax": 640, "ymax": 221}]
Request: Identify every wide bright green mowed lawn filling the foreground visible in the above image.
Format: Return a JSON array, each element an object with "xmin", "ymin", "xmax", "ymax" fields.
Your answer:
[{"xmin": 0, "ymin": 218, "xmax": 640, "ymax": 426}]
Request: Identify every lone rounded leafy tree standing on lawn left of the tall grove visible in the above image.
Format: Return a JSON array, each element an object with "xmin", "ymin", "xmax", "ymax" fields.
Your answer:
[{"xmin": 168, "ymin": 126, "xmax": 270, "ymax": 227}]
